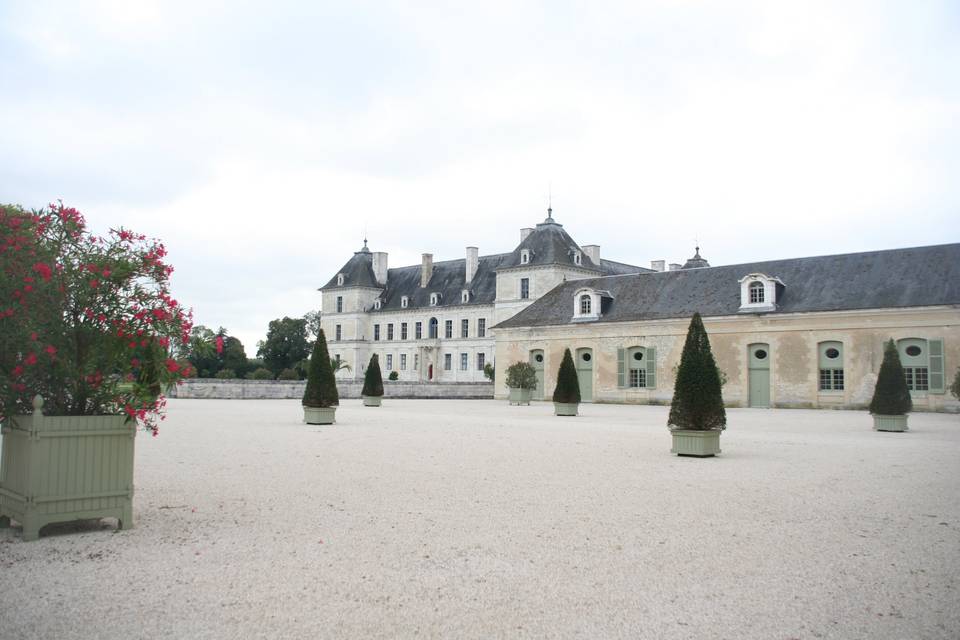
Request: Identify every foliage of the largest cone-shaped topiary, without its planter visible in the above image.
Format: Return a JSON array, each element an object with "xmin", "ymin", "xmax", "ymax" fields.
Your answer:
[{"xmin": 667, "ymin": 313, "xmax": 727, "ymax": 431}]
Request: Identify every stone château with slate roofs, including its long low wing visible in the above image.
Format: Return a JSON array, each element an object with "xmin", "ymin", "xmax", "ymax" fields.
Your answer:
[{"xmin": 321, "ymin": 210, "xmax": 960, "ymax": 411}]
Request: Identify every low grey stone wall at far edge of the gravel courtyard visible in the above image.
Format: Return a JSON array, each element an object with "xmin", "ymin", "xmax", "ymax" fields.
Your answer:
[{"xmin": 168, "ymin": 378, "xmax": 493, "ymax": 400}]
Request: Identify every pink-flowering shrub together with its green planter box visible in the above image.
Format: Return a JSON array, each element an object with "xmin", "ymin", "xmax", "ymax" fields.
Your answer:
[{"xmin": 0, "ymin": 203, "xmax": 191, "ymax": 540}]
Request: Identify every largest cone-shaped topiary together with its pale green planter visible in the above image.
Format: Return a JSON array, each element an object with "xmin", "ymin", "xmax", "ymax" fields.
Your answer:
[{"xmin": 667, "ymin": 313, "xmax": 727, "ymax": 458}]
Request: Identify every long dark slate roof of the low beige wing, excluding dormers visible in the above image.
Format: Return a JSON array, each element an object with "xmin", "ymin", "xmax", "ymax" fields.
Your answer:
[{"xmin": 497, "ymin": 244, "xmax": 960, "ymax": 328}]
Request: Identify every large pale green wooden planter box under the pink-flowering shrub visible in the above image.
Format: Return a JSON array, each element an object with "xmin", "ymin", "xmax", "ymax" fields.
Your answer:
[{"xmin": 0, "ymin": 396, "xmax": 137, "ymax": 540}]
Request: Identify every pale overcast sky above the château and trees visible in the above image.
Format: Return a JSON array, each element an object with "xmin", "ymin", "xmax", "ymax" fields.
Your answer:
[{"xmin": 0, "ymin": 0, "xmax": 960, "ymax": 357}]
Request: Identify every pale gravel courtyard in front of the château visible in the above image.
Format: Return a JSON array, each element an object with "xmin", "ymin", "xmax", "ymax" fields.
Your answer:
[{"xmin": 0, "ymin": 398, "xmax": 960, "ymax": 640}]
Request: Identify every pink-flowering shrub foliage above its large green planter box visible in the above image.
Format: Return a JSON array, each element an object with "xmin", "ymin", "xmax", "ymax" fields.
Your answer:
[{"xmin": 0, "ymin": 203, "xmax": 192, "ymax": 435}]
